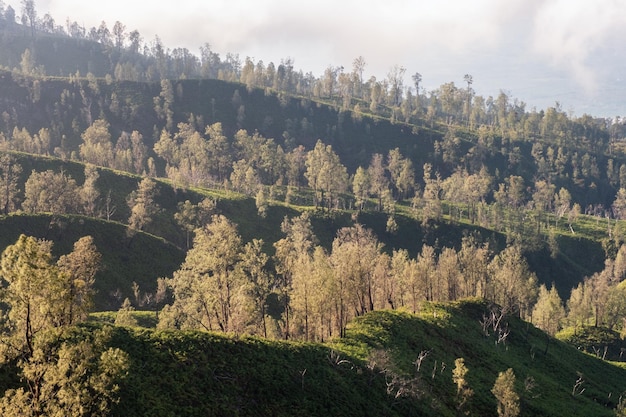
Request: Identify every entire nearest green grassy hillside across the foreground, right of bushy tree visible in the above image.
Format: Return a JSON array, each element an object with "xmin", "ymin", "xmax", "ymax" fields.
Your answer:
[{"xmin": 69, "ymin": 301, "xmax": 626, "ymax": 417}]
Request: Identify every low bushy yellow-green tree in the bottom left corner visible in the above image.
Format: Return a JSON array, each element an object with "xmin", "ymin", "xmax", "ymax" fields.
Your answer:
[{"xmin": 0, "ymin": 327, "xmax": 130, "ymax": 417}]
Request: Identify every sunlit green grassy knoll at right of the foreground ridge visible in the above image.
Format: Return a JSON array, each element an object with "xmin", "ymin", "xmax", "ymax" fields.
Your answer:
[{"xmin": 337, "ymin": 302, "xmax": 626, "ymax": 416}]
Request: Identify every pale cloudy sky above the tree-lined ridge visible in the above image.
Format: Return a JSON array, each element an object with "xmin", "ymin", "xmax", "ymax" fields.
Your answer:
[{"xmin": 4, "ymin": 0, "xmax": 626, "ymax": 117}]
